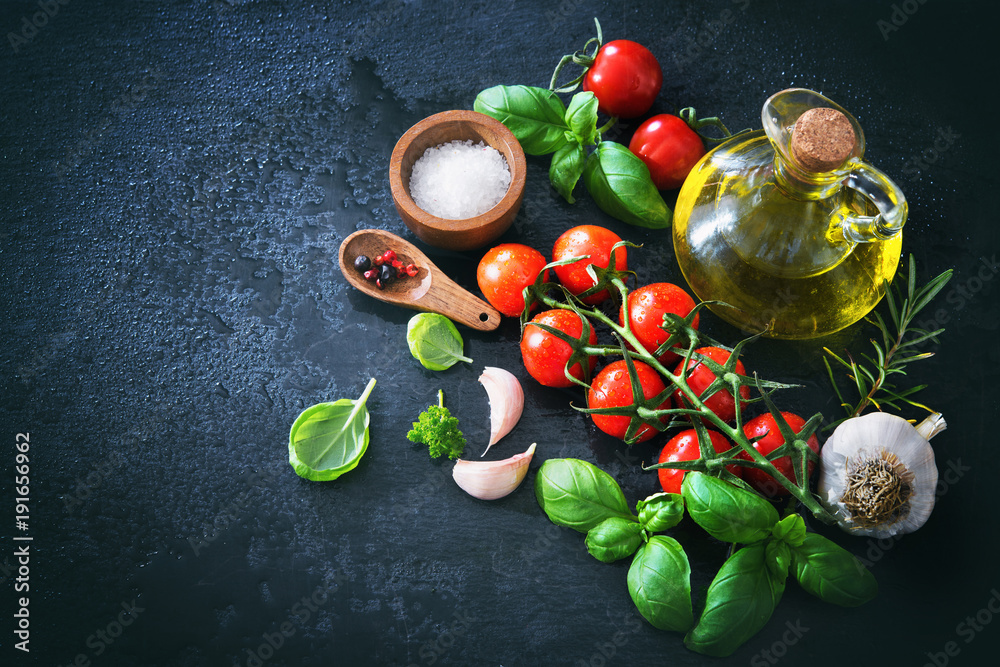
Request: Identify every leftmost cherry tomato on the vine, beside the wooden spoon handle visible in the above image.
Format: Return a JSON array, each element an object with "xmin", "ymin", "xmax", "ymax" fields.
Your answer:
[{"xmin": 476, "ymin": 243, "xmax": 548, "ymax": 317}]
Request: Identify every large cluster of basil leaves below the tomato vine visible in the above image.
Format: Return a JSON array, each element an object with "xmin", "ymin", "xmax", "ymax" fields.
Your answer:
[{"xmin": 535, "ymin": 459, "xmax": 878, "ymax": 657}]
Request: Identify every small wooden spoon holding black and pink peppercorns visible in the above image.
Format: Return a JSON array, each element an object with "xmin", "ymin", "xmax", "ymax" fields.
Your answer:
[{"xmin": 340, "ymin": 229, "xmax": 500, "ymax": 331}]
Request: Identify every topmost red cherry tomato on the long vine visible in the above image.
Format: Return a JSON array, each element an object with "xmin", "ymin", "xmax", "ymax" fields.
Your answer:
[{"xmin": 552, "ymin": 225, "xmax": 628, "ymax": 305}]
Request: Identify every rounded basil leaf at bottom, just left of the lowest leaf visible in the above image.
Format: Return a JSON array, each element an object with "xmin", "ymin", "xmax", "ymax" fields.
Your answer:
[{"xmin": 628, "ymin": 535, "xmax": 694, "ymax": 632}]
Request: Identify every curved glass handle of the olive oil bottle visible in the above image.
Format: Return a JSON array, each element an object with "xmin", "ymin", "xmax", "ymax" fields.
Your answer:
[{"xmin": 840, "ymin": 161, "xmax": 908, "ymax": 243}]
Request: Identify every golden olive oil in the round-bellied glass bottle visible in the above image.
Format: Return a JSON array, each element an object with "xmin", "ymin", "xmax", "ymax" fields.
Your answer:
[{"xmin": 674, "ymin": 91, "xmax": 905, "ymax": 338}]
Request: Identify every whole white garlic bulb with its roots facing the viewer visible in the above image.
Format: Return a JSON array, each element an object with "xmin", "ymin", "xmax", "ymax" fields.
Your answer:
[{"xmin": 818, "ymin": 412, "xmax": 946, "ymax": 539}]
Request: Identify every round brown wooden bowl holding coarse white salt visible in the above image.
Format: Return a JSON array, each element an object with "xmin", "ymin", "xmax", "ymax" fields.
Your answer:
[{"xmin": 389, "ymin": 110, "xmax": 526, "ymax": 250}]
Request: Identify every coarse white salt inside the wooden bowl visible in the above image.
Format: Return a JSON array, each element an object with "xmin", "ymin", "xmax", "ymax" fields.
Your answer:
[{"xmin": 410, "ymin": 140, "xmax": 510, "ymax": 220}]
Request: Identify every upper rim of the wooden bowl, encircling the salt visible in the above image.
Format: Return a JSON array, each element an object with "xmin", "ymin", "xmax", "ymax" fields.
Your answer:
[{"xmin": 389, "ymin": 109, "xmax": 527, "ymax": 232}]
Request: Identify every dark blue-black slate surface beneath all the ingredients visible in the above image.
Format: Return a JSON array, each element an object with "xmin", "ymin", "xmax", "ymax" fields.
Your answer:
[{"xmin": 0, "ymin": 0, "xmax": 1000, "ymax": 667}]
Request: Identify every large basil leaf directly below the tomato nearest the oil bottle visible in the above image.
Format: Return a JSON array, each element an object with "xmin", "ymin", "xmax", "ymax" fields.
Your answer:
[{"xmin": 583, "ymin": 141, "xmax": 673, "ymax": 229}]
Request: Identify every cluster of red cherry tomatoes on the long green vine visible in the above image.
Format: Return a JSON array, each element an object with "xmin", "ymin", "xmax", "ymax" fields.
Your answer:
[{"xmin": 477, "ymin": 225, "xmax": 819, "ymax": 497}]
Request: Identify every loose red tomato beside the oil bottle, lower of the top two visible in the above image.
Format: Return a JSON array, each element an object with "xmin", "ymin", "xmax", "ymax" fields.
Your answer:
[{"xmin": 628, "ymin": 114, "xmax": 705, "ymax": 190}]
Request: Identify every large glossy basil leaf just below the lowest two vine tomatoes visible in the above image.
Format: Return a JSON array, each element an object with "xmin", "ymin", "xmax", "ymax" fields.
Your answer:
[{"xmin": 681, "ymin": 470, "xmax": 778, "ymax": 544}]
